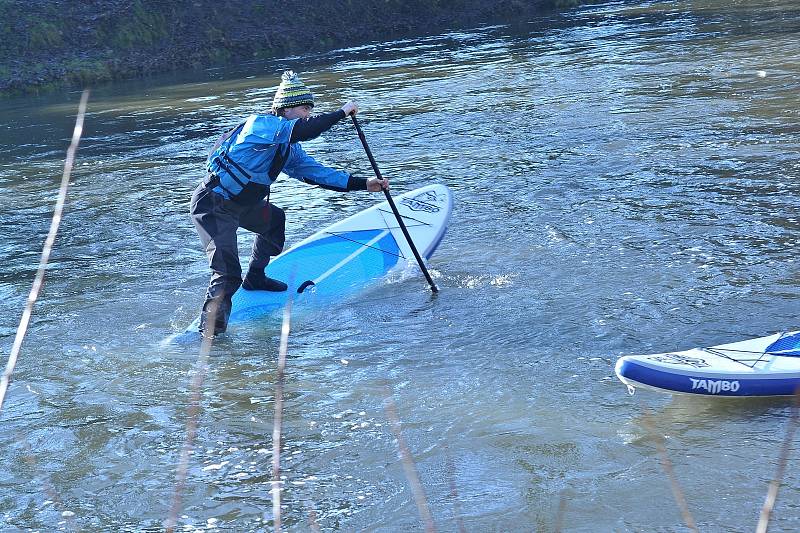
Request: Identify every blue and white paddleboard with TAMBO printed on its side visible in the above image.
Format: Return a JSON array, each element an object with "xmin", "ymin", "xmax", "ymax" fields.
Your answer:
[{"xmin": 614, "ymin": 331, "xmax": 800, "ymax": 396}]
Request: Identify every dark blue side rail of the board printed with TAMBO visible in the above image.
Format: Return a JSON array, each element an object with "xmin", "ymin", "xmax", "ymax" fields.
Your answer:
[{"xmin": 617, "ymin": 359, "xmax": 800, "ymax": 396}]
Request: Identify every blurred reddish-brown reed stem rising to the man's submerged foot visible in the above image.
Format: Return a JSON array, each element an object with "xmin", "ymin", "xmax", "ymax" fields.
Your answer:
[{"xmin": 164, "ymin": 305, "xmax": 219, "ymax": 533}]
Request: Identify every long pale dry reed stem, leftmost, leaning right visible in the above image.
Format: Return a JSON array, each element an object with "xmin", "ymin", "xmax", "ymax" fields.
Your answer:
[{"xmin": 0, "ymin": 89, "xmax": 89, "ymax": 411}]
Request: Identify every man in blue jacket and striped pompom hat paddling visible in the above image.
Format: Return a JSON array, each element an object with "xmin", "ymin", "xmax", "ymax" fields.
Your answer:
[{"xmin": 190, "ymin": 71, "xmax": 389, "ymax": 336}]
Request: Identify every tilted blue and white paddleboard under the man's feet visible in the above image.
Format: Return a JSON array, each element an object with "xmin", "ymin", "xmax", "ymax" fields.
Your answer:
[{"xmin": 168, "ymin": 184, "xmax": 453, "ymax": 341}]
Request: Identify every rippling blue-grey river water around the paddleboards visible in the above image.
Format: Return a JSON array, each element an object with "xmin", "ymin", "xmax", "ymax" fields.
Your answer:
[{"xmin": 0, "ymin": 0, "xmax": 800, "ymax": 532}]
